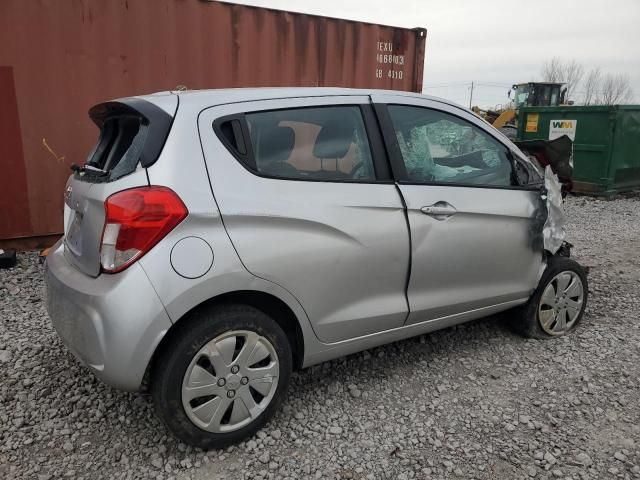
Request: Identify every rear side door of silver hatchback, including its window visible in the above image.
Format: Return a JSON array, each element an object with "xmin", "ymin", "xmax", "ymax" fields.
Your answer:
[{"xmin": 199, "ymin": 96, "xmax": 409, "ymax": 343}]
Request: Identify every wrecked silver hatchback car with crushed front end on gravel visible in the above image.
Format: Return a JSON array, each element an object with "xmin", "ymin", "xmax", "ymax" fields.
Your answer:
[{"xmin": 46, "ymin": 88, "xmax": 587, "ymax": 448}]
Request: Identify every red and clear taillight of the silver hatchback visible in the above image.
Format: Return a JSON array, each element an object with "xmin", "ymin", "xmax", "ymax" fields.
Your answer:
[{"xmin": 100, "ymin": 187, "xmax": 189, "ymax": 273}]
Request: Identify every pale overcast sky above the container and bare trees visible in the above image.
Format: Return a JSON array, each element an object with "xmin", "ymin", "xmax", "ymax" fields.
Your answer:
[{"xmin": 234, "ymin": 0, "xmax": 640, "ymax": 106}]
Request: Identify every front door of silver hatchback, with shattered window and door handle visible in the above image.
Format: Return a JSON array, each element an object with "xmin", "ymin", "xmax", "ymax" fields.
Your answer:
[{"xmin": 374, "ymin": 96, "xmax": 542, "ymax": 323}]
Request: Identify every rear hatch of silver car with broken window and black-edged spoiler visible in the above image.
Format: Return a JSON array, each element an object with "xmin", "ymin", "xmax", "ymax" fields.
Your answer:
[{"xmin": 64, "ymin": 94, "xmax": 178, "ymax": 277}]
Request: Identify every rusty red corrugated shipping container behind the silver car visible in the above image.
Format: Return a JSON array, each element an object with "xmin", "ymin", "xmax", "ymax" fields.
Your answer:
[{"xmin": 0, "ymin": 0, "xmax": 426, "ymax": 240}]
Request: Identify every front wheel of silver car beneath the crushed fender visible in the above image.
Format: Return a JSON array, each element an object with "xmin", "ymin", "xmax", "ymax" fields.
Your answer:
[{"xmin": 516, "ymin": 256, "xmax": 589, "ymax": 339}]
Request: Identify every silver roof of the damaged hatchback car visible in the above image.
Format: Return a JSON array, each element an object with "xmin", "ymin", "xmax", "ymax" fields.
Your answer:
[{"xmin": 138, "ymin": 87, "xmax": 464, "ymax": 108}]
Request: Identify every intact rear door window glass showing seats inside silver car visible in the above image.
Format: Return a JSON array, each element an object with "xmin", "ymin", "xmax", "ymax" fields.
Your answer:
[{"xmin": 245, "ymin": 106, "xmax": 376, "ymax": 182}]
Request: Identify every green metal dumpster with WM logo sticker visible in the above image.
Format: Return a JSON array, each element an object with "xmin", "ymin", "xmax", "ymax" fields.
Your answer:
[{"xmin": 518, "ymin": 105, "xmax": 640, "ymax": 195}]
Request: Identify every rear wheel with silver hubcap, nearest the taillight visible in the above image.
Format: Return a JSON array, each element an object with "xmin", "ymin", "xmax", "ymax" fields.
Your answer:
[{"xmin": 151, "ymin": 305, "xmax": 292, "ymax": 450}]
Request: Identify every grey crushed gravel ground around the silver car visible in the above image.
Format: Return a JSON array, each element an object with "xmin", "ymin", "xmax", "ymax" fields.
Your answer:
[{"xmin": 0, "ymin": 197, "xmax": 640, "ymax": 480}]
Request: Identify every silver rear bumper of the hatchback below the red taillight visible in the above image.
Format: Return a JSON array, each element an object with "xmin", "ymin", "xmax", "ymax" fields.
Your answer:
[{"xmin": 45, "ymin": 241, "xmax": 171, "ymax": 391}]
